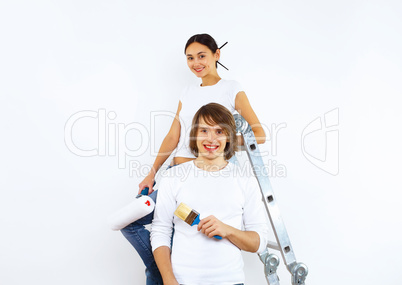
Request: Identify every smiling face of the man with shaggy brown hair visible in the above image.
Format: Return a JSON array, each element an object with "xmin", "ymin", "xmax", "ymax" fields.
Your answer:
[{"xmin": 197, "ymin": 117, "xmax": 227, "ymax": 160}]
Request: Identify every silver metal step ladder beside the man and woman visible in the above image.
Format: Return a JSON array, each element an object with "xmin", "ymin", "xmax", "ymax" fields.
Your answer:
[{"xmin": 234, "ymin": 114, "xmax": 308, "ymax": 285}]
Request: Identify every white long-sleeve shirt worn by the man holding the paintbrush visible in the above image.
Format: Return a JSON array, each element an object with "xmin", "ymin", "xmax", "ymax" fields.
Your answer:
[{"xmin": 151, "ymin": 161, "xmax": 268, "ymax": 285}]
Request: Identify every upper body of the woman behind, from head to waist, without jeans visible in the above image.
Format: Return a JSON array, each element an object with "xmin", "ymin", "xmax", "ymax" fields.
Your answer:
[{"xmin": 139, "ymin": 34, "xmax": 265, "ymax": 192}]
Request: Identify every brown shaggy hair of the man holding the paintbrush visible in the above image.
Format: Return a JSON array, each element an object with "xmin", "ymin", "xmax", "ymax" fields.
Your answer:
[{"xmin": 190, "ymin": 103, "xmax": 237, "ymax": 160}]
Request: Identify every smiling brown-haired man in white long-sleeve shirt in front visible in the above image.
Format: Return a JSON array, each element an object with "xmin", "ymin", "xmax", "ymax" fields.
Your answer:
[{"xmin": 151, "ymin": 103, "xmax": 268, "ymax": 285}]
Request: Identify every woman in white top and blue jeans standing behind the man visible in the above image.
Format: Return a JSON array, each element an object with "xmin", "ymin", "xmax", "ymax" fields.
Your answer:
[{"xmin": 121, "ymin": 34, "xmax": 265, "ymax": 285}]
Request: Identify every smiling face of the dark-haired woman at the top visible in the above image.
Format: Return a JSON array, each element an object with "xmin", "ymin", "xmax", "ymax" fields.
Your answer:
[{"xmin": 186, "ymin": 42, "xmax": 220, "ymax": 78}]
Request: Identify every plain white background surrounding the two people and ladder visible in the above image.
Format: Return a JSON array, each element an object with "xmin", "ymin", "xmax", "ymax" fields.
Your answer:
[{"xmin": 0, "ymin": 0, "xmax": 402, "ymax": 285}]
